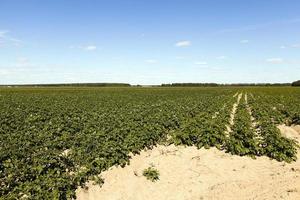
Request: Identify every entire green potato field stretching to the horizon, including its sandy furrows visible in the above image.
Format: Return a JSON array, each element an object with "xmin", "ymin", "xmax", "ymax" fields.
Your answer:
[{"xmin": 0, "ymin": 87, "xmax": 300, "ymax": 199}]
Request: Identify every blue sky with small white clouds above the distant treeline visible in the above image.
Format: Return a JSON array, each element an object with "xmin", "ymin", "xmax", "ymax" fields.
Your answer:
[{"xmin": 0, "ymin": 0, "xmax": 300, "ymax": 84}]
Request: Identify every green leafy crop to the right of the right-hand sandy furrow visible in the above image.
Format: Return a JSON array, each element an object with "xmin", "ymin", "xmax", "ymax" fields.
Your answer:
[{"xmin": 246, "ymin": 89, "xmax": 300, "ymax": 162}]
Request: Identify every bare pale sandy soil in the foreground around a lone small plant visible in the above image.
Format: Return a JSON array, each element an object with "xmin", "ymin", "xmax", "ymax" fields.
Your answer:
[{"xmin": 77, "ymin": 126, "xmax": 300, "ymax": 200}]
